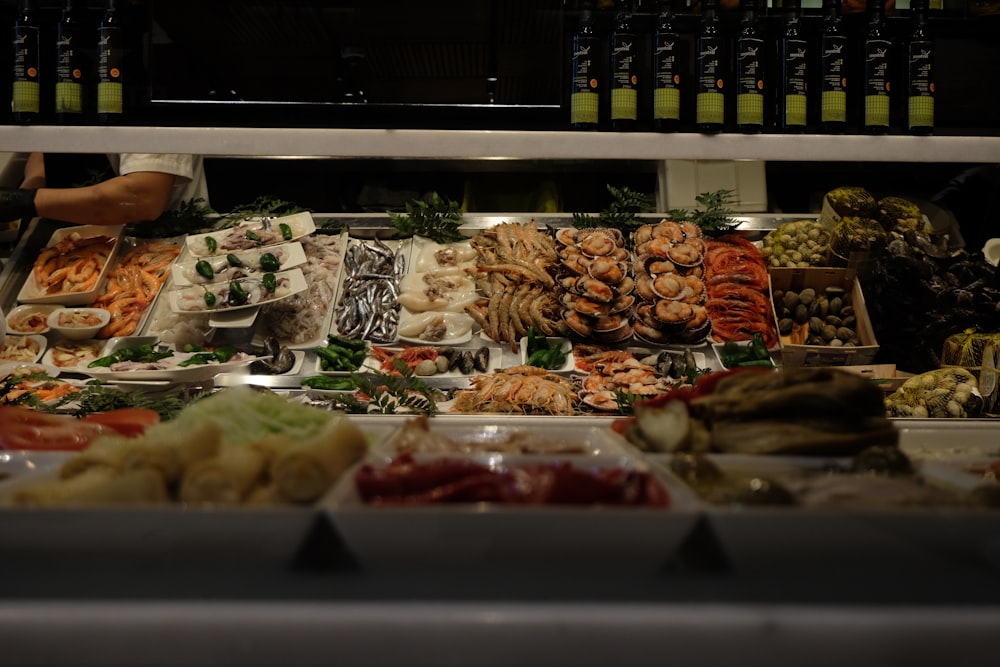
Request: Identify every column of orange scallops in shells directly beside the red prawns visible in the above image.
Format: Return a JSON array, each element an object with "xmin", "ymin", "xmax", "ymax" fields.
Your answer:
[{"xmin": 633, "ymin": 219, "xmax": 714, "ymax": 345}]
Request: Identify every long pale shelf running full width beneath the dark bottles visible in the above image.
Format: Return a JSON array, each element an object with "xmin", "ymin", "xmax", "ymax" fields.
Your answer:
[{"xmin": 0, "ymin": 126, "xmax": 1000, "ymax": 163}]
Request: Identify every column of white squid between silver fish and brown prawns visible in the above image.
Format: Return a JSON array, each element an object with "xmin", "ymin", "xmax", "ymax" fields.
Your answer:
[{"xmin": 399, "ymin": 238, "xmax": 479, "ymax": 344}]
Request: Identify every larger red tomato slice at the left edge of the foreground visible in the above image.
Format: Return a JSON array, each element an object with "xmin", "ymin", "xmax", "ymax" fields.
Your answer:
[{"xmin": 0, "ymin": 406, "xmax": 105, "ymax": 451}]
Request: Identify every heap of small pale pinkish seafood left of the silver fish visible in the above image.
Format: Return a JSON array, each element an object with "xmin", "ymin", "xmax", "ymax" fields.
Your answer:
[{"xmin": 258, "ymin": 234, "xmax": 347, "ymax": 348}]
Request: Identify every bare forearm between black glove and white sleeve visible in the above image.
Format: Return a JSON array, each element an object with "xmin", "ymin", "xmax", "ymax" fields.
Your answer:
[{"xmin": 35, "ymin": 171, "xmax": 174, "ymax": 225}]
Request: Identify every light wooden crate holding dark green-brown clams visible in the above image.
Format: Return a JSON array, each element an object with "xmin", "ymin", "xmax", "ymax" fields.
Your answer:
[{"xmin": 771, "ymin": 267, "xmax": 878, "ymax": 367}]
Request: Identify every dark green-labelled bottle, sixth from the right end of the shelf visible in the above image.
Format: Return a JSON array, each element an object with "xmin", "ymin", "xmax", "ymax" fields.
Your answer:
[{"xmin": 695, "ymin": 0, "xmax": 726, "ymax": 132}]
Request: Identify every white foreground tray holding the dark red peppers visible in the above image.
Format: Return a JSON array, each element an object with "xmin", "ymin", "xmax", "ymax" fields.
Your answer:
[{"xmin": 321, "ymin": 446, "xmax": 698, "ymax": 572}]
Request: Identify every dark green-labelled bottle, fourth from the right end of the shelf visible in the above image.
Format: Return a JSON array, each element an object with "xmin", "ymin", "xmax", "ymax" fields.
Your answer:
[{"xmin": 776, "ymin": 0, "xmax": 809, "ymax": 132}]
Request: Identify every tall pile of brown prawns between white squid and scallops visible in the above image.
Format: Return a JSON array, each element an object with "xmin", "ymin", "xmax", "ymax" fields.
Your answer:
[{"xmin": 465, "ymin": 222, "xmax": 567, "ymax": 350}]
